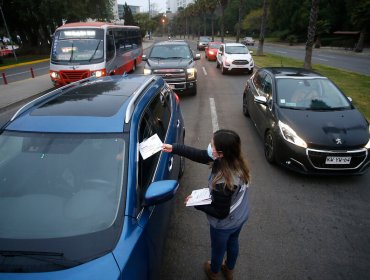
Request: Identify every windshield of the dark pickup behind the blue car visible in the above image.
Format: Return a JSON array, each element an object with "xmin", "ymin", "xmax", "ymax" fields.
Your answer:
[{"xmin": 149, "ymin": 45, "xmax": 192, "ymax": 59}]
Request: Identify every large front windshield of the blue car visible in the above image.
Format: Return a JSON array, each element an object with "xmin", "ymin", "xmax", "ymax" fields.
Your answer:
[{"xmin": 0, "ymin": 133, "xmax": 125, "ymax": 239}]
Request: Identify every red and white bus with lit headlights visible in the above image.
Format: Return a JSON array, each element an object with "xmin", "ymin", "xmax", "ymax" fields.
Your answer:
[{"xmin": 50, "ymin": 22, "xmax": 143, "ymax": 86}]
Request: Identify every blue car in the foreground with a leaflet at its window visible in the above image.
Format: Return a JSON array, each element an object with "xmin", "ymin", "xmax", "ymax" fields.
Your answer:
[{"xmin": 0, "ymin": 75, "xmax": 185, "ymax": 280}]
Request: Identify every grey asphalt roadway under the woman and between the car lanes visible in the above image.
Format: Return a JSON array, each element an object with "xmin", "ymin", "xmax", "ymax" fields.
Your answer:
[{"xmin": 0, "ymin": 40, "xmax": 370, "ymax": 280}]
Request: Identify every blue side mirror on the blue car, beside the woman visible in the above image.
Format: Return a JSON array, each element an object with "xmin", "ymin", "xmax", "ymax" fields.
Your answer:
[{"xmin": 143, "ymin": 180, "xmax": 179, "ymax": 206}]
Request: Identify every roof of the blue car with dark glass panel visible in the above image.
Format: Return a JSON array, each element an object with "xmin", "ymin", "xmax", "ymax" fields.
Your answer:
[{"xmin": 5, "ymin": 75, "xmax": 158, "ymax": 133}]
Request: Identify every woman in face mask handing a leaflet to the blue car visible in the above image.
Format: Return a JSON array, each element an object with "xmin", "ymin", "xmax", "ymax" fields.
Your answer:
[{"xmin": 163, "ymin": 129, "xmax": 250, "ymax": 280}]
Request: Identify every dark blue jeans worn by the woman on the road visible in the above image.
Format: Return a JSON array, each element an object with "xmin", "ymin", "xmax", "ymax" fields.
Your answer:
[{"xmin": 210, "ymin": 224, "xmax": 243, "ymax": 273}]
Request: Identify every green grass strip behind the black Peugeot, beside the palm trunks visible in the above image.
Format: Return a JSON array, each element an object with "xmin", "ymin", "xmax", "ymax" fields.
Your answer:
[{"xmin": 253, "ymin": 53, "xmax": 370, "ymax": 120}]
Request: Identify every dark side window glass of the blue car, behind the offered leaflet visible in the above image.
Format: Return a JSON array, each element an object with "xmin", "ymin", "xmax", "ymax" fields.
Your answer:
[{"xmin": 137, "ymin": 87, "xmax": 172, "ymax": 206}]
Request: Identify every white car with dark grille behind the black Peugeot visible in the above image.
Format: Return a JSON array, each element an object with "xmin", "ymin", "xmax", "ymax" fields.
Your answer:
[{"xmin": 216, "ymin": 43, "xmax": 254, "ymax": 74}]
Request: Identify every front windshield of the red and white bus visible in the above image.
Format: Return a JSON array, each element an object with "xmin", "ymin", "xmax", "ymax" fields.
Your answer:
[{"xmin": 51, "ymin": 29, "xmax": 104, "ymax": 64}]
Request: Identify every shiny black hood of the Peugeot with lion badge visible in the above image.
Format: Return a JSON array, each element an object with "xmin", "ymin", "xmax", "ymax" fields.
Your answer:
[{"xmin": 278, "ymin": 108, "xmax": 369, "ymax": 149}]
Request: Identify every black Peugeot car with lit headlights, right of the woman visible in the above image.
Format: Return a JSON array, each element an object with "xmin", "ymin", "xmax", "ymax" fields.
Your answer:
[{"xmin": 243, "ymin": 67, "xmax": 370, "ymax": 175}]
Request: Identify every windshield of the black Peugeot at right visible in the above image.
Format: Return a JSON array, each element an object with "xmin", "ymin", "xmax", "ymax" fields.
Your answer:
[{"xmin": 276, "ymin": 78, "xmax": 351, "ymax": 110}]
